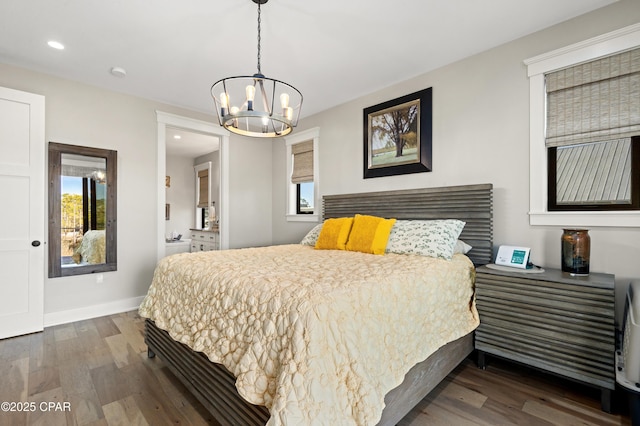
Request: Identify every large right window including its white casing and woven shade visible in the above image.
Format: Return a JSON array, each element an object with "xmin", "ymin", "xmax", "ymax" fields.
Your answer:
[{"xmin": 525, "ymin": 24, "xmax": 640, "ymax": 230}]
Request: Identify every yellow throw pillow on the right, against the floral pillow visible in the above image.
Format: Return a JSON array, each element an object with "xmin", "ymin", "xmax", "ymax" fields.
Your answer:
[{"xmin": 347, "ymin": 214, "xmax": 396, "ymax": 254}]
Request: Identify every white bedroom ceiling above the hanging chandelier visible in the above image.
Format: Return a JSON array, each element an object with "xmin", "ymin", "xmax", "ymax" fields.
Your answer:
[{"xmin": 0, "ymin": 0, "xmax": 615, "ymax": 154}]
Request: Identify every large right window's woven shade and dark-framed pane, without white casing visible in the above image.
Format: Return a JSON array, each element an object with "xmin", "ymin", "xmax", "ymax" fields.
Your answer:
[{"xmin": 545, "ymin": 48, "xmax": 640, "ymax": 211}]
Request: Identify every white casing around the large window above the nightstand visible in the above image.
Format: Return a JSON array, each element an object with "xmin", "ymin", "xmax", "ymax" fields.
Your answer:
[{"xmin": 525, "ymin": 24, "xmax": 640, "ymax": 227}]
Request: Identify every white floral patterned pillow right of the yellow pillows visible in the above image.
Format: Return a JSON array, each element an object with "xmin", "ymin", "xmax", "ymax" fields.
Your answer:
[{"xmin": 386, "ymin": 219, "xmax": 465, "ymax": 260}]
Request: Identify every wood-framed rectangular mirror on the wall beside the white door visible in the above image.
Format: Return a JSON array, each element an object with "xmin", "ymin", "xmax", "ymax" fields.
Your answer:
[{"xmin": 49, "ymin": 142, "xmax": 117, "ymax": 278}]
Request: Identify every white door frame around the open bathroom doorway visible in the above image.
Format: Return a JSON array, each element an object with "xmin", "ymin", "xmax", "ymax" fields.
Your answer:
[{"xmin": 156, "ymin": 111, "xmax": 230, "ymax": 260}]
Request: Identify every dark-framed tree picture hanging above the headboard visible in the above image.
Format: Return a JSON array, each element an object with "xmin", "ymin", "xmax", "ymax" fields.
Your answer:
[{"xmin": 364, "ymin": 87, "xmax": 432, "ymax": 179}]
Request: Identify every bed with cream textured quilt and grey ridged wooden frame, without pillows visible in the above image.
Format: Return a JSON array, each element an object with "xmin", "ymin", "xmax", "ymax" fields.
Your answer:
[{"xmin": 140, "ymin": 184, "xmax": 492, "ymax": 425}]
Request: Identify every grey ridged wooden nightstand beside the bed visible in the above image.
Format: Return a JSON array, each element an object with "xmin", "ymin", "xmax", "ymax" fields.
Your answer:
[{"xmin": 475, "ymin": 266, "xmax": 615, "ymax": 412}]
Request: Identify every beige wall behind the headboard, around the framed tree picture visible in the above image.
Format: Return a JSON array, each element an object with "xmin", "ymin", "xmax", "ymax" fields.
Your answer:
[{"xmin": 273, "ymin": 0, "xmax": 640, "ymax": 322}]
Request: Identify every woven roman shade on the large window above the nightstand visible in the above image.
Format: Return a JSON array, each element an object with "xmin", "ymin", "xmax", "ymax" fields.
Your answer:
[{"xmin": 546, "ymin": 48, "xmax": 640, "ymax": 147}]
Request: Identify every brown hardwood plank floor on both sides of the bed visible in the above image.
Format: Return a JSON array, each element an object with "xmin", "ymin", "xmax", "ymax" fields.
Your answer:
[{"xmin": 0, "ymin": 312, "xmax": 631, "ymax": 426}]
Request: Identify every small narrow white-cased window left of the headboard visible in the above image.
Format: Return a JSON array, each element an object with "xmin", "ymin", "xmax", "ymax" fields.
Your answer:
[{"xmin": 285, "ymin": 128, "xmax": 320, "ymax": 222}]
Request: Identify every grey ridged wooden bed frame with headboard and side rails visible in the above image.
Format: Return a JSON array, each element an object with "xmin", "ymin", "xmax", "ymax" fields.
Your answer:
[{"xmin": 145, "ymin": 184, "xmax": 493, "ymax": 426}]
